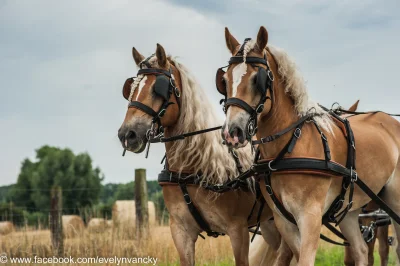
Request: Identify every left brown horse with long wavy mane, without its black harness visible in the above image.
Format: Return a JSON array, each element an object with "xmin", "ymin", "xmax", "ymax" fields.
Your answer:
[{"xmin": 118, "ymin": 44, "xmax": 290, "ymax": 265}]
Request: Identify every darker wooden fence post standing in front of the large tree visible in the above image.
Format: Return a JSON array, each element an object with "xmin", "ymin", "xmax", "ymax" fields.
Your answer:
[{"xmin": 50, "ymin": 186, "xmax": 64, "ymax": 256}]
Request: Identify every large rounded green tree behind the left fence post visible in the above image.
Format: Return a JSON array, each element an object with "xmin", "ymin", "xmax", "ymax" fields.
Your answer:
[{"xmin": 12, "ymin": 146, "xmax": 103, "ymax": 213}]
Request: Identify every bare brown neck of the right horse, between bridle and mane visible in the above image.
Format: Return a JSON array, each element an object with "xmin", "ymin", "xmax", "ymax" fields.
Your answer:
[{"xmin": 257, "ymin": 75, "xmax": 299, "ymax": 158}]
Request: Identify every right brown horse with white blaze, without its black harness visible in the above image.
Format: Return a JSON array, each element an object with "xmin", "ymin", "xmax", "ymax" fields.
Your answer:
[{"xmin": 217, "ymin": 27, "xmax": 400, "ymax": 265}]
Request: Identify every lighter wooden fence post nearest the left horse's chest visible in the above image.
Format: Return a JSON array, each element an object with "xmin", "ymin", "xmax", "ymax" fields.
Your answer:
[{"xmin": 135, "ymin": 169, "xmax": 149, "ymax": 240}]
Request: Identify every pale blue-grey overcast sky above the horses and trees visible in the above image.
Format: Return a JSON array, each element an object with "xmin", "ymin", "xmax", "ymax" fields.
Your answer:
[{"xmin": 0, "ymin": 0, "xmax": 400, "ymax": 185}]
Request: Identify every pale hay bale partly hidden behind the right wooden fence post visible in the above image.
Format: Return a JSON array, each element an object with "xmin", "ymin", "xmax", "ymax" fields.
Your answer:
[{"xmin": 112, "ymin": 200, "xmax": 156, "ymax": 227}]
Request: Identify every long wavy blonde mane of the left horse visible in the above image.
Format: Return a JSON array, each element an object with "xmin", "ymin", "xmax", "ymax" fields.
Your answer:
[{"xmin": 168, "ymin": 57, "xmax": 252, "ymax": 184}]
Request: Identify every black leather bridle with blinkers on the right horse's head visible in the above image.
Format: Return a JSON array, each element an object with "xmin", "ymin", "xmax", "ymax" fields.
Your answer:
[{"xmin": 216, "ymin": 38, "xmax": 274, "ymax": 139}]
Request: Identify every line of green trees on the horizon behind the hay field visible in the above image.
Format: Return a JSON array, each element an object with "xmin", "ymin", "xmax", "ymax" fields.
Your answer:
[{"xmin": 0, "ymin": 146, "xmax": 165, "ymax": 225}]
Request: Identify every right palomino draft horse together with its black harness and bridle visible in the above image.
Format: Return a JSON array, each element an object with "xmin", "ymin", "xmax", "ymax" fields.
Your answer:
[{"xmin": 220, "ymin": 27, "xmax": 400, "ymax": 265}]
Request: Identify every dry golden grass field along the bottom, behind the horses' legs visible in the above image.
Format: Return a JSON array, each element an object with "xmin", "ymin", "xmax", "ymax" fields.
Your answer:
[{"xmin": 0, "ymin": 226, "xmax": 396, "ymax": 265}]
